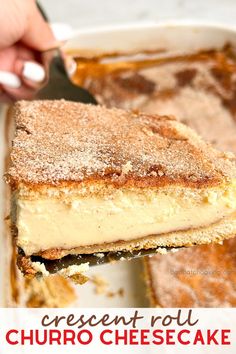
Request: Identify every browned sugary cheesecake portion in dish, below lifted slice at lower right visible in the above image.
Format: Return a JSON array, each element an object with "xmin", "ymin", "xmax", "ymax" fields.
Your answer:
[{"xmin": 148, "ymin": 239, "xmax": 236, "ymax": 307}]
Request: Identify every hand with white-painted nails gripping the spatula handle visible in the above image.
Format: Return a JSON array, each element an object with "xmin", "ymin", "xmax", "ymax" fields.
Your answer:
[{"xmin": 0, "ymin": 0, "xmax": 58, "ymax": 102}]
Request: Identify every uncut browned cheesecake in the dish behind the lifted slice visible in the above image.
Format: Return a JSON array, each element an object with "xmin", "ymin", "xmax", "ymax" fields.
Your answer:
[{"xmin": 72, "ymin": 45, "xmax": 236, "ymax": 151}]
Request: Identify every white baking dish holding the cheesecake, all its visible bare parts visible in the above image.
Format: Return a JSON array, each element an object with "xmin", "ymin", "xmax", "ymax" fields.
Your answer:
[{"xmin": 0, "ymin": 21, "xmax": 236, "ymax": 307}]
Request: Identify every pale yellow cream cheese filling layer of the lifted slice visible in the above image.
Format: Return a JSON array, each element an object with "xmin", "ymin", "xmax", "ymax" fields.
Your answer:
[{"xmin": 13, "ymin": 184, "xmax": 236, "ymax": 255}]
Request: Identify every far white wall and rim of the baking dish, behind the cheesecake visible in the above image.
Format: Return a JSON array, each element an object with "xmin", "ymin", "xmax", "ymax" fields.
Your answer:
[{"xmin": 62, "ymin": 21, "xmax": 236, "ymax": 56}]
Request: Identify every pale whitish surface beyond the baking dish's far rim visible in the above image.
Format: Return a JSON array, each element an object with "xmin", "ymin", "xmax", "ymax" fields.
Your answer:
[{"xmin": 40, "ymin": 0, "xmax": 236, "ymax": 28}]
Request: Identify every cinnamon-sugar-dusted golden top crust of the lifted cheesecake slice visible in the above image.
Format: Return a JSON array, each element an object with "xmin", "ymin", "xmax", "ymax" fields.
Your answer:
[{"xmin": 6, "ymin": 100, "xmax": 236, "ymax": 187}]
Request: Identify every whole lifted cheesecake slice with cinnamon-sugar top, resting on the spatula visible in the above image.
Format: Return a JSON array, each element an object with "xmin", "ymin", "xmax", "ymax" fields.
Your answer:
[{"xmin": 6, "ymin": 100, "xmax": 236, "ymax": 276}]
